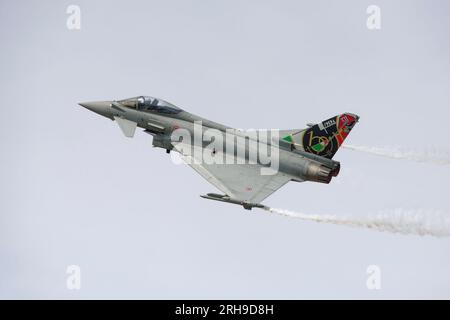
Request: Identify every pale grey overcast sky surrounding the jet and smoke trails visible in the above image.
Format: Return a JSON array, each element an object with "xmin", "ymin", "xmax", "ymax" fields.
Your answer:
[{"xmin": 0, "ymin": 0, "xmax": 450, "ymax": 299}]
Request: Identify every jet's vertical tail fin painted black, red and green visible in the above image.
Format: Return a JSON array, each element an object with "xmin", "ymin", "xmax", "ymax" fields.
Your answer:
[{"xmin": 282, "ymin": 113, "xmax": 359, "ymax": 159}]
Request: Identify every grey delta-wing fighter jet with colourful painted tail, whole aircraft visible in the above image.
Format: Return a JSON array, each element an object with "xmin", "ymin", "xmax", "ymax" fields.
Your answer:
[{"xmin": 79, "ymin": 96, "xmax": 359, "ymax": 210}]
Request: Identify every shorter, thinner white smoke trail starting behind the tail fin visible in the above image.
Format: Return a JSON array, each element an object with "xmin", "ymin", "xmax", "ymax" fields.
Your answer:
[{"xmin": 342, "ymin": 144, "xmax": 450, "ymax": 165}]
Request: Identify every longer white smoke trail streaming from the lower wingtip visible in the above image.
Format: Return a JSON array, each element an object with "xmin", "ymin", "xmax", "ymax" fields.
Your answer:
[{"xmin": 264, "ymin": 207, "xmax": 450, "ymax": 237}]
